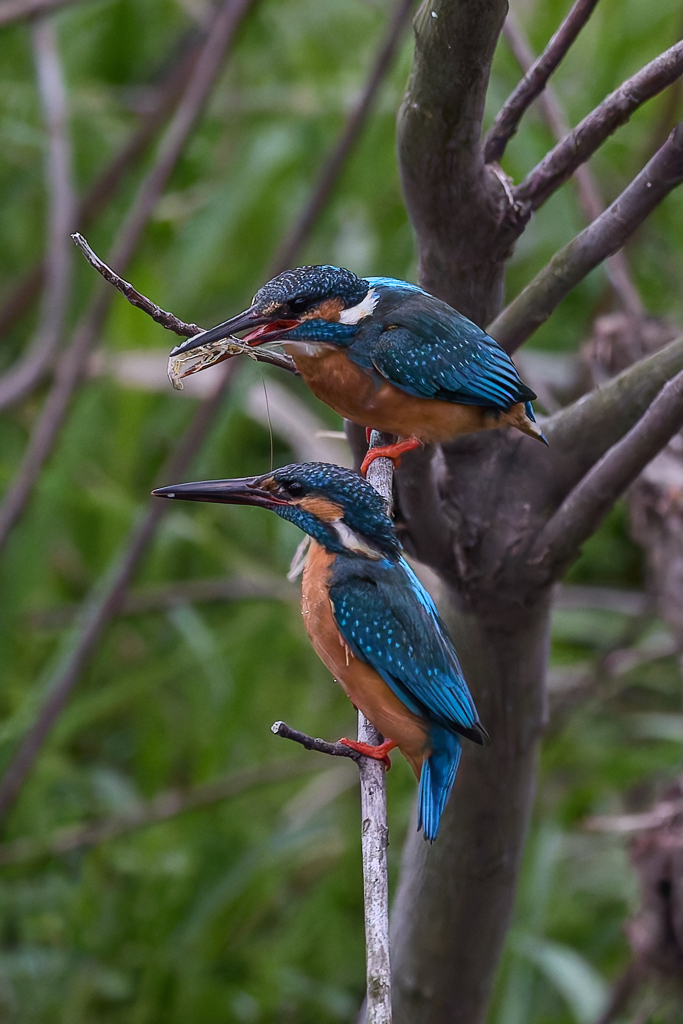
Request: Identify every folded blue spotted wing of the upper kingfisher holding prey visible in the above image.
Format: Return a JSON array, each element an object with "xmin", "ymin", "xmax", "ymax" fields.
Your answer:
[{"xmin": 371, "ymin": 296, "xmax": 536, "ymax": 410}]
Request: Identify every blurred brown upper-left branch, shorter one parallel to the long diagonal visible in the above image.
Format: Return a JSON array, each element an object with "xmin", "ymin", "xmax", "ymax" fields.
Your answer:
[{"xmin": 0, "ymin": 32, "xmax": 204, "ymax": 344}]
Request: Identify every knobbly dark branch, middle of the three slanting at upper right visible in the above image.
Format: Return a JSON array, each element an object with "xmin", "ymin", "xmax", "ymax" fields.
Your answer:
[{"xmin": 513, "ymin": 42, "xmax": 683, "ymax": 210}]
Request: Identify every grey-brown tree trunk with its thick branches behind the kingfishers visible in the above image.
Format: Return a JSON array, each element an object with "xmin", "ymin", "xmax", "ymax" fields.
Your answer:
[{"xmin": 392, "ymin": 9, "xmax": 683, "ymax": 1024}]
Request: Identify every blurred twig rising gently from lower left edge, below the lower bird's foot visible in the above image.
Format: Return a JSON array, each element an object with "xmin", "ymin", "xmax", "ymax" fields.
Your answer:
[{"xmin": 0, "ymin": 748, "xmax": 317, "ymax": 867}]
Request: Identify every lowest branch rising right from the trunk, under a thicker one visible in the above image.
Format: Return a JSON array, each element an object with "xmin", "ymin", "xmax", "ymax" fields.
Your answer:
[{"xmin": 530, "ymin": 371, "xmax": 683, "ymax": 574}]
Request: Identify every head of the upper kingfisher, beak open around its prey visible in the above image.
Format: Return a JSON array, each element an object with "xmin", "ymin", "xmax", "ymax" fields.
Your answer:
[{"xmin": 171, "ymin": 266, "xmax": 379, "ymax": 365}]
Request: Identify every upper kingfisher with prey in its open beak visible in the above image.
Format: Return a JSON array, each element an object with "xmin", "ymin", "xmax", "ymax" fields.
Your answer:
[{"xmin": 165, "ymin": 266, "xmax": 547, "ymax": 472}]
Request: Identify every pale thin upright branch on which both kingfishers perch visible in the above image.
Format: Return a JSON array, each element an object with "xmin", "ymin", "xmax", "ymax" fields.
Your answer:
[{"xmin": 358, "ymin": 430, "xmax": 393, "ymax": 1024}]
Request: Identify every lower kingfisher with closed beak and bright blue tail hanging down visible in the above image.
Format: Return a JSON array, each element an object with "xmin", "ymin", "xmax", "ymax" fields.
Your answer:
[{"xmin": 153, "ymin": 462, "xmax": 486, "ymax": 841}]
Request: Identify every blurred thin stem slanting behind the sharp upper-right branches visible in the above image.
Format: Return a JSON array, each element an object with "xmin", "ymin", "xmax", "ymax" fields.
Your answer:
[{"xmin": 503, "ymin": 10, "xmax": 643, "ymax": 322}]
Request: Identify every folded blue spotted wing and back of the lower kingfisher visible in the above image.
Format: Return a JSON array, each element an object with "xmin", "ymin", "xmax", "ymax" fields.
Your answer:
[{"xmin": 330, "ymin": 559, "xmax": 478, "ymax": 735}]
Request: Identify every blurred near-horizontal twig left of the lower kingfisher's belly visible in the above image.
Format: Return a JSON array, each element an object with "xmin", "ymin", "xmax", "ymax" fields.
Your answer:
[{"xmin": 27, "ymin": 574, "xmax": 296, "ymax": 630}]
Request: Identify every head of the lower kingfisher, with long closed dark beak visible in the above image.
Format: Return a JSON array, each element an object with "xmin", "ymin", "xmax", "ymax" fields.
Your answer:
[{"xmin": 153, "ymin": 462, "xmax": 400, "ymax": 562}]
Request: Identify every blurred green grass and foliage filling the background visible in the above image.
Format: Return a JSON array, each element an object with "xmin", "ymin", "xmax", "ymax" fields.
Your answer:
[{"xmin": 0, "ymin": 0, "xmax": 683, "ymax": 1024}]
